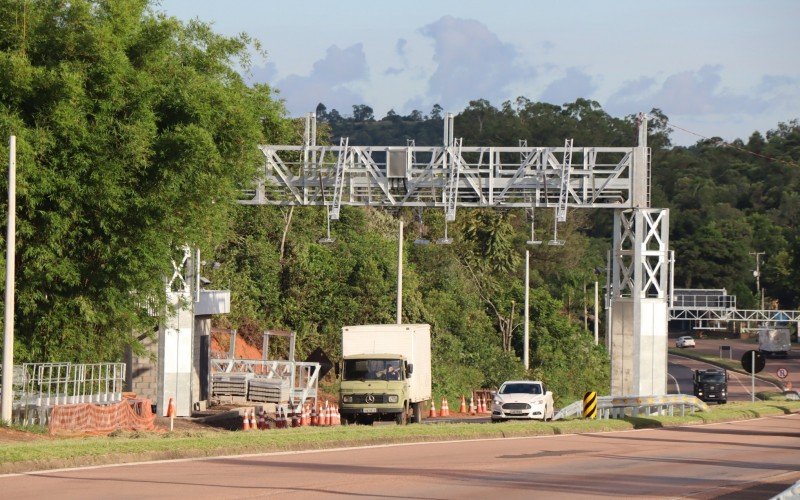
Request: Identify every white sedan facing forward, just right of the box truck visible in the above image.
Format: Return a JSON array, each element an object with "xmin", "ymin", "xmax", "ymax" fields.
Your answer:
[{"xmin": 492, "ymin": 380, "xmax": 555, "ymax": 422}]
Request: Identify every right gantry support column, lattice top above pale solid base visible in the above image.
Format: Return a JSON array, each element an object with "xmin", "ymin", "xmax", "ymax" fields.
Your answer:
[{"xmin": 610, "ymin": 208, "xmax": 669, "ymax": 396}]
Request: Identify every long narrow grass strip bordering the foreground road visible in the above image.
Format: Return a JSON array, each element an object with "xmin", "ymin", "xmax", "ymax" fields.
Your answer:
[{"xmin": 0, "ymin": 401, "xmax": 800, "ymax": 473}]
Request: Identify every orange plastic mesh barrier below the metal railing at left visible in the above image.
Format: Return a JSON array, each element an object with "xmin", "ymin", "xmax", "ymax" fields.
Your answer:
[{"xmin": 49, "ymin": 399, "xmax": 156, "ymax": 435}]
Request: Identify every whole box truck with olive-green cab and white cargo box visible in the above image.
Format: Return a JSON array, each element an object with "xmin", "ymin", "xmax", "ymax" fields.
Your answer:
[{"xmin": 339, "ymin": 324, "xmax": 431, "ymax": 425}]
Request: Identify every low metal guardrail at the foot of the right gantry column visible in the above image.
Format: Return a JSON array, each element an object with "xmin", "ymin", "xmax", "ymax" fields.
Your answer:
[{"xmin": 553, "ymin": 394, "xmax": 708, "ymax": 420}]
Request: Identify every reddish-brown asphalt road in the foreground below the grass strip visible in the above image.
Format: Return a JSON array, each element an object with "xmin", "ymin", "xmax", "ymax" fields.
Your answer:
[{"xmin": 0, "ymin": 415, "xmax": 800, "ymax": 500}]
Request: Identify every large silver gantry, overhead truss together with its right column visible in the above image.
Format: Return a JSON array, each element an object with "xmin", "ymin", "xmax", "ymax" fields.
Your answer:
[{"xmin": 244, "ymin": 113, "xmax": 669, "ymax": 396}]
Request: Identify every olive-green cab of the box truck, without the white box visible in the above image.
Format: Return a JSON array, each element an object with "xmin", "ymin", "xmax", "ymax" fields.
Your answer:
[{"xmin": 339, "ymin": 354, "xmax": 413, "ymax": 424}]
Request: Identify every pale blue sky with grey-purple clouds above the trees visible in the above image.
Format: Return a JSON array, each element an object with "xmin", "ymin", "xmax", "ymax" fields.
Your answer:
[{"xmin": 156, "ymin": 0, "xmax": 800, "ymax": 146}]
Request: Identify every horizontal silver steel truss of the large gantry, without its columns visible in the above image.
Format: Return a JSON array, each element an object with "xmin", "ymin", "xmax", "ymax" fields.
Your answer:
[{"xmin": 239, "ymin": 117, "xmax": 650, "ymax": 221}]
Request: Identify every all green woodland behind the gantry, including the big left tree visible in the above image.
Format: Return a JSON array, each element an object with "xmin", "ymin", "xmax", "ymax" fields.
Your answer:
[{"xmin": 0, "ymin": 0, "xmax": 800, "ymax": 400}]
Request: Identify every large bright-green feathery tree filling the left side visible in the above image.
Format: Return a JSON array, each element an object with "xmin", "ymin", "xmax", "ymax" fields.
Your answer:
[{"xmin": 0, "ymin": 0, "xmax": 288, "ymax": 361}]
